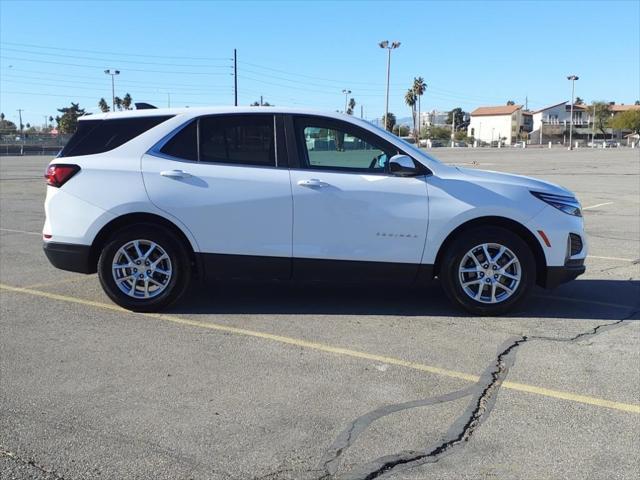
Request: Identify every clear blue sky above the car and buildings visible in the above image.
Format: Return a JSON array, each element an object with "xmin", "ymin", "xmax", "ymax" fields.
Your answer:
[{"xmin": 0, "ymin": 0, "xmax": 640, "ymax": 125}]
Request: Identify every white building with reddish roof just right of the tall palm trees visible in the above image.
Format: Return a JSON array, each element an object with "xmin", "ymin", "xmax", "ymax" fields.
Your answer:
[{"xmin": 467, "ymin": 105, "xmax": 524, "ymax": 145}]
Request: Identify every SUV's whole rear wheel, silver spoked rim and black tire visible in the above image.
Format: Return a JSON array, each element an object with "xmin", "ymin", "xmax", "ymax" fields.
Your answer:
[{"xmin": 98, "ymin": 225, "xmax": 191, "ymax": 312}]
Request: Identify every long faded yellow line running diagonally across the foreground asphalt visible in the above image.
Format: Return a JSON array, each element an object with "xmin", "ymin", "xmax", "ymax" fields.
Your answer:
[{"xmin": 0, "ymin": 283, "xmax": 640, "ymax": 413}]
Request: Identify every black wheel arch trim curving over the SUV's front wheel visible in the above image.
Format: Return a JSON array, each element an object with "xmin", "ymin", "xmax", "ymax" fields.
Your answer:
[{"xmin": 433, "ymin": 216, "xmax": 547, "ymax": 285}]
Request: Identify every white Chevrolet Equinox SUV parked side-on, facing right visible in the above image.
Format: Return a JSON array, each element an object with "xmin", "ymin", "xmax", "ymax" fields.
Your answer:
[{"xmin": 43, "ymin": 107, "xmax": 587, "ymax": 315}]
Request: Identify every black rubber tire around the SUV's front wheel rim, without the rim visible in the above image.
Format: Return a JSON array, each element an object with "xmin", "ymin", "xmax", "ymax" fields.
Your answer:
[{"xmin": 439, "ymin": 226, "xmax": 536, "ymax": 316}]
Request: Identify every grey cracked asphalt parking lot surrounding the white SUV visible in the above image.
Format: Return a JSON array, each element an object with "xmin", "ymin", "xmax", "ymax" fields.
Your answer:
[{"xmin": 0, "ymin": 148, "xmax": 640, "ymax": 480}]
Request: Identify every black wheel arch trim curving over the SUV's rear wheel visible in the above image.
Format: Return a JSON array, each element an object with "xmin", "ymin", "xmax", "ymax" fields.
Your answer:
[{"xmin": 89, "ymin": 212, "xmax": 202, "ymax": 273}]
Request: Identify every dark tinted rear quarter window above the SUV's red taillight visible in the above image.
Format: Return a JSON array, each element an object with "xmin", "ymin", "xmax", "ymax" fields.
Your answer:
[{"xmin": 59, "ymin": 115, "xmax": 172, "ymax": 157}]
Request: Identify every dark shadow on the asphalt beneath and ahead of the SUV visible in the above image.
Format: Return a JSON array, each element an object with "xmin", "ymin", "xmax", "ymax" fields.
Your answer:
[{"xmin": 171, "ymin": 279, "xmax": 640, "ymax": 320}]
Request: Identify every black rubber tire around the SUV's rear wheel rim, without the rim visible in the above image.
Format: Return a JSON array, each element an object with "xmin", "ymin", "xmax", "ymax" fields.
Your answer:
[{"xmin": 98, "ymin": 224, "xmax": 191, "ymax": 312}]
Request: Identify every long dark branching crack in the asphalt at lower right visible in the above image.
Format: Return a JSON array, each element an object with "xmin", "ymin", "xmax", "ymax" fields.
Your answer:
[{"xmin": 319, "ymin": 309, "xmax": 640, "ymax": 480}]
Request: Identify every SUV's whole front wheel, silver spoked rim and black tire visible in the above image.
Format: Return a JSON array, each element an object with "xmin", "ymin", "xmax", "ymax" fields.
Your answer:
[{"xmin": 439, "ymin": 227, "xmax": 536, "ymax": 315}]
